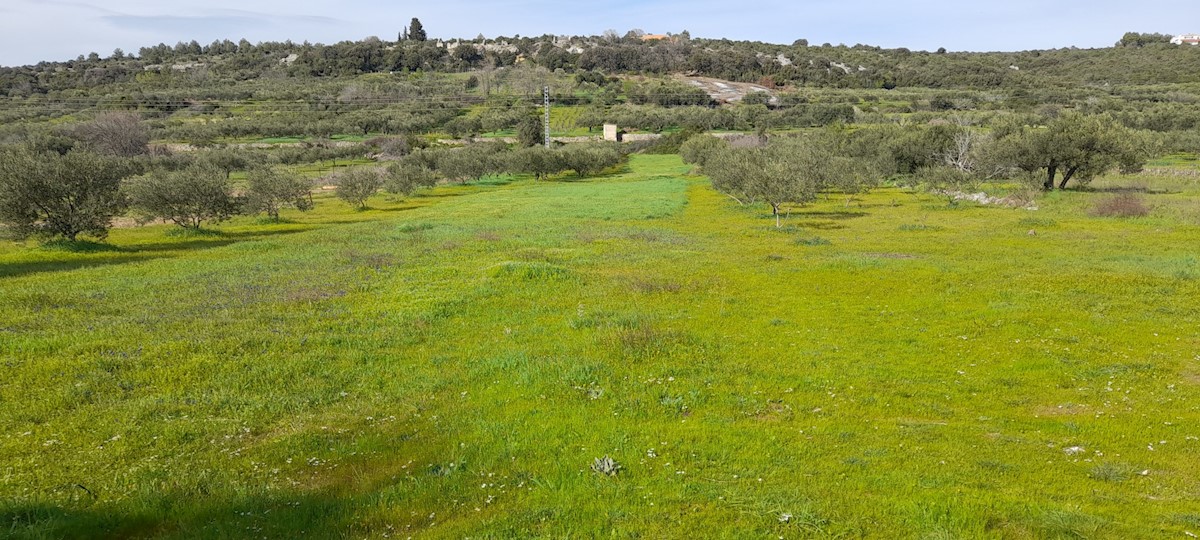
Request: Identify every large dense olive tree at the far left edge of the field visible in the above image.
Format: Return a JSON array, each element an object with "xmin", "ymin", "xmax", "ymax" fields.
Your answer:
[{"xmin": 0, "ymin": 149, "xmax": 134, "ymax": 241}]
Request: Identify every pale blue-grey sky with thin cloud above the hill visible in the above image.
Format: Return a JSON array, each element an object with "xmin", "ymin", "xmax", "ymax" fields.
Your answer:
[{"xmin": 0, "ymin": 0, "xmax": 1200, "ymax": 66}]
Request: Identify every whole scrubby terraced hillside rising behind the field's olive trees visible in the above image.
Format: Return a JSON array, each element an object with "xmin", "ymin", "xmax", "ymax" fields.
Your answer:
[{"xmin": 0, "ymin": 30, "xmax": 1200, "ymax": 151}]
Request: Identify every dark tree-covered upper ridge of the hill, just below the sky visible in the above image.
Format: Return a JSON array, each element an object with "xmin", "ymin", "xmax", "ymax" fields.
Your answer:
[{"xmin": 7, "ymin": 32, "xmax": 1200, "ymax": 97}]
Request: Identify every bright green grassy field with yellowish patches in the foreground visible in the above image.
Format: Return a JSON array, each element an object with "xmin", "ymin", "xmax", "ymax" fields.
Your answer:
[{"xmin": 0, "ymin": 156, "xmax": 1200, "ymax": 539}]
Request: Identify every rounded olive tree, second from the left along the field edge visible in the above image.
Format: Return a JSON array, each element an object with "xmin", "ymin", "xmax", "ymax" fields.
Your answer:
[{"xmin": 125, "ymin": 162, "xmax": 240, "ymax": 229}]
